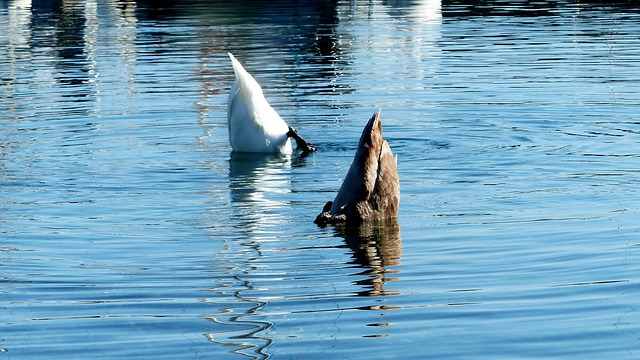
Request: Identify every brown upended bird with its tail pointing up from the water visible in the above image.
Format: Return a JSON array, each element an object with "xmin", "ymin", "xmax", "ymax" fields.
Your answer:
[{"xmin": 314, "ymin": 111, "xmax": 400, "ymax": 224}]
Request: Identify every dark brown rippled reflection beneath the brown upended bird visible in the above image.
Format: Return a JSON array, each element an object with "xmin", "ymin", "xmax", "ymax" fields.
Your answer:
[{"xmin": 334, "ymin": 219, "xmax": 402, "ymax": 296}]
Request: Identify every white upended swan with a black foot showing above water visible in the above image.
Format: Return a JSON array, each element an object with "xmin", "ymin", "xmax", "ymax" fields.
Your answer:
[{"xmin": 227, "ymin": 53, "xmax": 316, "ymax": 154}]
